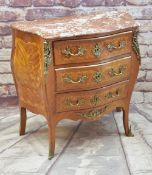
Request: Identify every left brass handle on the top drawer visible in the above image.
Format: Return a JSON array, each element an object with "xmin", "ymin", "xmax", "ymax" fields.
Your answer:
[{"xmin": 62, "ymin": 47, "xmax": 86, "ymax": 57}]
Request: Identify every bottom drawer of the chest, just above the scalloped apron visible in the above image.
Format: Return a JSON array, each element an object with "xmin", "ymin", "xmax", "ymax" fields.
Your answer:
[{"xmin": 56, "ymin": 81, "xmax": 128, "ymax": 112}]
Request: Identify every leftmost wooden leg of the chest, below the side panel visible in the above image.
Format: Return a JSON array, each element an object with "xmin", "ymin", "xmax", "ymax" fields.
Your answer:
[{"xmin": 19, "ymin": 107, "xmax": 27, "ymax": 135}]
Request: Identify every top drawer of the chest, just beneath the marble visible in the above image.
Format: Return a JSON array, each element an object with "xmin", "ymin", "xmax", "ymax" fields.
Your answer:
[{"xmin": 54, "ymin": 31, "xmax": 132, "ymax": 65}]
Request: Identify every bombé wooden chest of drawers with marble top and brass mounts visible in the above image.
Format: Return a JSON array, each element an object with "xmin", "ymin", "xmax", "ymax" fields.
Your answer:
[{"xmin": 11, "ymin": 12, "xmax": 140, "ymax": 158}]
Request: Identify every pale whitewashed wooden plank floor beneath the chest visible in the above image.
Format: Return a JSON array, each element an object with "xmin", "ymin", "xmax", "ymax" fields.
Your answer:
[{"xmin": 0, "ymin": 104, "xmax": 152, "ymax": 175}]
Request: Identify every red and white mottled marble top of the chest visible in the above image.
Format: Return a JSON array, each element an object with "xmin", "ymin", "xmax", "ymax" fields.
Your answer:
[{"xmin": 12, "ymin": 11, "xmax": 139, "ymax": 39}]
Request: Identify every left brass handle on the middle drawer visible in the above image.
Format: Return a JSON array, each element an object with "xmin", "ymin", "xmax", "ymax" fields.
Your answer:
[{"xmin": 64, "ymin": 75, "xmax": 88, "ymax": 84}]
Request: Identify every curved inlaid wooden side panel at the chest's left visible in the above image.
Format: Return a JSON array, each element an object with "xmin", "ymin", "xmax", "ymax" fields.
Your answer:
[{"xmin": 12, "ymin": 32, "xmax": 46, "ymax": 114}]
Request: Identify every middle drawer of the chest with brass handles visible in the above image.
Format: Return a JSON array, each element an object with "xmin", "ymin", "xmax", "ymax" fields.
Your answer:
[{"xmin": 56, "ymin": 57, "xmax": 131, "ymax": 92}]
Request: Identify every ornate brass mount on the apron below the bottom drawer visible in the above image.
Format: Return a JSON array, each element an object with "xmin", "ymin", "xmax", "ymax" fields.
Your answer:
[{"xmin": 80, "ymin": 106, "xmax": 108, "ymax": 118}]
